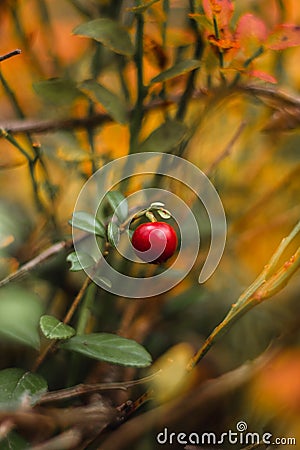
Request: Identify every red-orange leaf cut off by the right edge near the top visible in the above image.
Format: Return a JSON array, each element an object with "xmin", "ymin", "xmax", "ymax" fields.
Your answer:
[{"xmin": 267, "ymin": 23, "xmax": 300, "ymax": 50}]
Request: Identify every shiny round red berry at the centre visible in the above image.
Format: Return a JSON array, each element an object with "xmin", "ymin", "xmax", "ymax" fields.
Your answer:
[{"xmin": 132, "ymin": 222, "xmax": 177, "ymax": 264}]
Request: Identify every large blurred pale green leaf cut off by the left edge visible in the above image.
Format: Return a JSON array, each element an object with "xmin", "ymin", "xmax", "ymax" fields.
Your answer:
[{"xmin": 0, "ymin": 287, "xmax": 43, "ymax": 350}]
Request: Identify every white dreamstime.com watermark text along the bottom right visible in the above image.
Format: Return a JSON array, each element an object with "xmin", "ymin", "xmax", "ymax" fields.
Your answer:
[{"xmin": 156, "ymin": 420, "xmax": 296, "ymax": 446}]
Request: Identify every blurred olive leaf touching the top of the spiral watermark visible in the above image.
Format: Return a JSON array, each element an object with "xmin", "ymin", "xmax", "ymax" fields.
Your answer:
[{"xmin": 139, "ymin": 120, "xmax": 187, "ymax": 152}]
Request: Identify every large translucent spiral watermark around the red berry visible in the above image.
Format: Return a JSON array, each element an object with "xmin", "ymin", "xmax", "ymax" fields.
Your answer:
[{"xmin": 72, "ymin": 152, "xmax": 226, "ymax": 298}]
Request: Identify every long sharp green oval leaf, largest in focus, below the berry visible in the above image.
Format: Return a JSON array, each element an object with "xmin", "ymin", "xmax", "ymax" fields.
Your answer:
[{"xmin": 60, "ymin": 333, "xmax": 152, "ymax": 367}]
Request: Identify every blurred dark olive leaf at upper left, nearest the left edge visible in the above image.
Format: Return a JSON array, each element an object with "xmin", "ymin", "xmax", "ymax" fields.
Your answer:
[{"xmin": 33, "ymin": 78, "xmax": 84, "ymax": 106}]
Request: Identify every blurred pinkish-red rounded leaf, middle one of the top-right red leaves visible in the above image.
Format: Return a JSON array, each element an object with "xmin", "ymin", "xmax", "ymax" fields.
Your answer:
[{"xmin": 235, "ymin": 14, "xmax": 268, "ymax": 51}]
